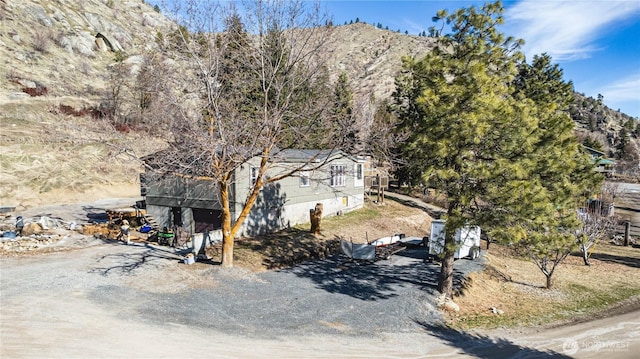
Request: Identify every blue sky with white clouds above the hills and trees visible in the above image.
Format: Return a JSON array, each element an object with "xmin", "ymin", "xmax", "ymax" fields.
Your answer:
[{"xmin": 323, "ymin": 0, "xmax": 640, "ymax": 117}]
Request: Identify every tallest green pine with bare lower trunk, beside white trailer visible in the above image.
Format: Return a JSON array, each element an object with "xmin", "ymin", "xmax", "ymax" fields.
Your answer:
[{"xmin": 394, "ymin": 3, "xmax": 536, "ymax": 297}]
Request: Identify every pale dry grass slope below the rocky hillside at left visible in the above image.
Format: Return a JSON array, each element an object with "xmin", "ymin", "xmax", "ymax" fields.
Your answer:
[{"xmin": 0, "ymin": 98, "xmax": 168, "ymax": 207}]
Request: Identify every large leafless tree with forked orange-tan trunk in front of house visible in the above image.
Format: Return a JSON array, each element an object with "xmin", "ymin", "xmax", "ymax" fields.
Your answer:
[{"xmin": 144, "ymin": 0, "xmax": 337, "ymax": 267}]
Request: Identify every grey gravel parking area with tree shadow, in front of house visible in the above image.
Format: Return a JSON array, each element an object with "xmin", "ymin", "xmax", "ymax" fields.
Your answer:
[{"xmin": 134, "ymin": 245, "xmax": 479, "ymax": 336}]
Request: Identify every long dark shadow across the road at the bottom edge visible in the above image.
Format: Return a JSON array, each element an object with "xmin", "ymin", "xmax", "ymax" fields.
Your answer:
[{"xmin": 416, "ymin": 321, "xmax": 571, "ymax": 359}]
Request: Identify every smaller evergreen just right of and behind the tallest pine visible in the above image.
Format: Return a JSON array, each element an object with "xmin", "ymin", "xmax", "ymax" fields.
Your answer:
[{"xmin": 496, "ymin": 54, "xmax": 603, "ymax": 288}]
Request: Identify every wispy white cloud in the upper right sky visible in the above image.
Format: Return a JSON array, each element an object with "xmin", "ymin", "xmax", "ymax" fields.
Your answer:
[{"xmin": 505, "ymin": 0, "xmax": 640, "ymax": 61}]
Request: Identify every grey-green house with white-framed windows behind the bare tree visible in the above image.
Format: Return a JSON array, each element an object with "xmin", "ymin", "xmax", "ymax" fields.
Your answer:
[{"xmin": 142, "ymin": 150, "xmax": 364, "ymax": 240}]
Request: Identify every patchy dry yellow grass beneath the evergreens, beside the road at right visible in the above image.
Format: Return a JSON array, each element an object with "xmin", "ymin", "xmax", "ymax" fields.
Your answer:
[{"xmin": 448, "ymin": 240, "xmax": 640, "ymax": 329}]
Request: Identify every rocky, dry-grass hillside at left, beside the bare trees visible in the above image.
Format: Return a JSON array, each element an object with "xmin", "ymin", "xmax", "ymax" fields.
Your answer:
[{"xmin": 0, "ymin": 0, "xmax": 172, "ymax": 206}]
